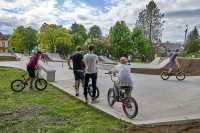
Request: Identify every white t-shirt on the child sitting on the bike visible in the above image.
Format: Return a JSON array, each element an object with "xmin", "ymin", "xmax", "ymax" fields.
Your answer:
[{"xmin": 113, "ymin": 64, "xmax": 133, "ymax": 87}]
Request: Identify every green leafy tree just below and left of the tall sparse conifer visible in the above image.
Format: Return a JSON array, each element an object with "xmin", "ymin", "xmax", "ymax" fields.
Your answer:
[{"xmin": 131, "ymin": 27, "xmax": 154, "ymax": 58}]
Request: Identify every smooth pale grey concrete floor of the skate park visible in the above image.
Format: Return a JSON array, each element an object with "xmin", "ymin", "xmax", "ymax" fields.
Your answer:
[{"xmin": 0, "ymin": 58, "xmax": 200, "ymax": 124}]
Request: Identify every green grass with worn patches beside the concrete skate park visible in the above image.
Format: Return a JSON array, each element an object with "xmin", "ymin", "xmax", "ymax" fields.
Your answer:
[{"xmin": 0, "ymin": 67, "xmax": 129, "ymax": 133}]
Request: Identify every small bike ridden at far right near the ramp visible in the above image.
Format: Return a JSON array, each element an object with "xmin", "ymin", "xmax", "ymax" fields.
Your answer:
[{"xmin": 160, "ymin": 69, "xmax": 186, "ymax": 81}]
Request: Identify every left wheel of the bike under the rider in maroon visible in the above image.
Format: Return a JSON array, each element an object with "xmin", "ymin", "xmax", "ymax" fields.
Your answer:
[{"xmin": 11, "ymin": 80, "xmax": 25, "ymax": 92}]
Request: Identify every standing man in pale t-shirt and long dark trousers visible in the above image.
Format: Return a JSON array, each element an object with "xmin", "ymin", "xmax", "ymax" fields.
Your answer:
[{"xmin": 83, "ymin": 45, "xmax": 98, "ymax": 103}]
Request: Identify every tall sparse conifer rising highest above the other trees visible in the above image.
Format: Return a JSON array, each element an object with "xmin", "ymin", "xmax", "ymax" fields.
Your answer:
[{"xmin": 136, "ymin": 0, "xmax": 164, "ymax": 42}]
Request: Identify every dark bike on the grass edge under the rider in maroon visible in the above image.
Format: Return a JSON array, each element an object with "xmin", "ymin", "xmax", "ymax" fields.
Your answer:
[{"xmin": 11, "ymin": 70, "xmax": 47, "ymax": 92}]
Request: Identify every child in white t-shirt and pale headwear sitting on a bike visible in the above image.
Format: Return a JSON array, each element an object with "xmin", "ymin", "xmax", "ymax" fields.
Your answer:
[{"xmin": 111, "ymin": 57, "xmax": 133, "ymax": 96}]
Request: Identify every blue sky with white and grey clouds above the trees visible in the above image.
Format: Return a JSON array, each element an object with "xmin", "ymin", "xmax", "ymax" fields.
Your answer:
[{"xmin": 0, "ymin": 0, "xmax": 200, "ymax": 42}]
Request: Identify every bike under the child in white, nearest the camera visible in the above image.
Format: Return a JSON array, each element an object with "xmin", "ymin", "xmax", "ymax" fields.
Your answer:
[{"xmin": 105, "ymin": 72, "xmax": 138, "ymax": 119}]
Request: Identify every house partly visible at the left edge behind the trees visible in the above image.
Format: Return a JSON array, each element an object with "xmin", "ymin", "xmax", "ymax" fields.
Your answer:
[{"xmin": 0, "ymin": 32, "xmax": 8, "ymax": 53}]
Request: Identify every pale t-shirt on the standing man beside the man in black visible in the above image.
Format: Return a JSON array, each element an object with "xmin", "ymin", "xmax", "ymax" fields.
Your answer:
[{"xmin": 83, "ymin": 54, "xmax": 98, "ymax": 74}]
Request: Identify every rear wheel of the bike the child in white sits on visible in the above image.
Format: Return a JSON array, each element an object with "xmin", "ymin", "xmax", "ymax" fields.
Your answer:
[{"xmin": 122, "ymin": 97, "xmax": 138, "ymax": 119}]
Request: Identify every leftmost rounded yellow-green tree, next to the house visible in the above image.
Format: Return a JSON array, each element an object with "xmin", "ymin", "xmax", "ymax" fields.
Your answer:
[{"xmin": 9, "ymin": 26, "xmax": 37, "ymax": 52}]
